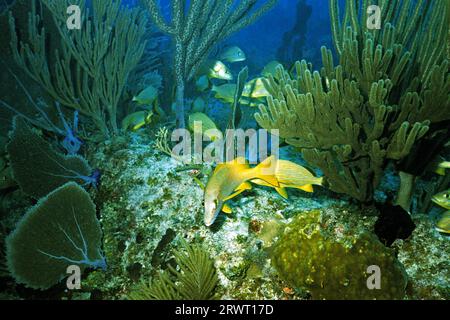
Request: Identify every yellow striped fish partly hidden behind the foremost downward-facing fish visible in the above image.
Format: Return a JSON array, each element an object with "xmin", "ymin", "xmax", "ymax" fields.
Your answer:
[{"xmin": 251, "ymin": 156, "xmax": 323, "ymax": 199}]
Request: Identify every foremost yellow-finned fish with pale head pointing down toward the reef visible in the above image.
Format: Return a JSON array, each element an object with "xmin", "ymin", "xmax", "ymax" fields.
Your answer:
[{"xmin": 204, "ymin": 158, "xmax": 279, "ymax": 227}]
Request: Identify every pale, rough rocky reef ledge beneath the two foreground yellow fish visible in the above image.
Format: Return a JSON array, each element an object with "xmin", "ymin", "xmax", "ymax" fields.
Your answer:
[{"xmin": 77, "ymin": 133, "xmax": 450, "ymax": 299}]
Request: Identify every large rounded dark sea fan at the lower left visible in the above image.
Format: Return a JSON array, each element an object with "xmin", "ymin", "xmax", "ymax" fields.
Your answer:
[{"xmin": 6, "ymin": 182, "xmax": 106, "ymax": 289}]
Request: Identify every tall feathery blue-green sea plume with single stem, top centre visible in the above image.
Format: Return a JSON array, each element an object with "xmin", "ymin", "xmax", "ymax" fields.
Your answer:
[{"xmin": 145, "ymin": 0, "xmax": 277, "ymax": 127}]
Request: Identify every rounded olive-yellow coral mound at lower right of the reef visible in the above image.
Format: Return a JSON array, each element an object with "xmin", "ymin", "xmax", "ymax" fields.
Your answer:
[{"xmin": 271, "ymin": 211, "xmax": 407, "ymax": 299}]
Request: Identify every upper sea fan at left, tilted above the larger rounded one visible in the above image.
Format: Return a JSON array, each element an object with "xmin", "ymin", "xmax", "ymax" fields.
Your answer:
[{"xmin": 7, "ymin": 117, "xmax": 93, "ymax": 199}]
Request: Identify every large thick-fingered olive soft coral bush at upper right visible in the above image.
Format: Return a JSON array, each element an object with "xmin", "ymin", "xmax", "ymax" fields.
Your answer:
[{"xmin": 255, "ymin": 0, "xmax": 450, "ymax": 202}]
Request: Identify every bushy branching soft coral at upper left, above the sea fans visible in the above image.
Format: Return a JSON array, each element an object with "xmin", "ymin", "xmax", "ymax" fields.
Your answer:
[{"xmin": 9, "ymin": 0, "xmax": 146, "ymax": 136}]
